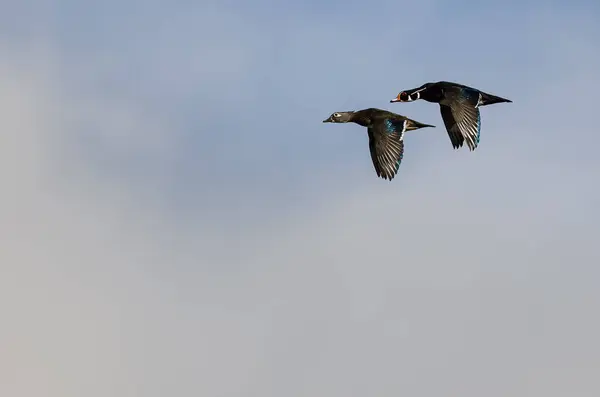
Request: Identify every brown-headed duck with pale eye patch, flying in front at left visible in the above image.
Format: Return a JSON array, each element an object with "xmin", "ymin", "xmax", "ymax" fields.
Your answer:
[{"xmin": 323, "ymin": 108, "xmax": 435, "ymax": 181}]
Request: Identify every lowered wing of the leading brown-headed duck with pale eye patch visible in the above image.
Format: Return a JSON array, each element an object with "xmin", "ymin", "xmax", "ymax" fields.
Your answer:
[{"xmin": 368, "ymin": 119, "xmax": 407, "ymax": 181}]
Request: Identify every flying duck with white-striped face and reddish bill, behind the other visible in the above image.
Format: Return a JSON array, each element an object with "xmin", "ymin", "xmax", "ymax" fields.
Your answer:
[{"xmin": 390, "ymin": 81, "xmax": 512, "ymax": 151}]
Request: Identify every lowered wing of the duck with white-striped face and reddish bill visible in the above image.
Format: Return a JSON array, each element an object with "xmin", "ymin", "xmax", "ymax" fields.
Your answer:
[{"xmin": 440, "ymin": 98, "xmax": 481, "ymax": 151}]
